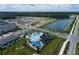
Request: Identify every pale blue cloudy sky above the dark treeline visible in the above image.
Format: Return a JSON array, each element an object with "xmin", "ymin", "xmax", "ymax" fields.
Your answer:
[{"xmin": 0, "ymin": 4, "xmax": 79, "ymax": 12}]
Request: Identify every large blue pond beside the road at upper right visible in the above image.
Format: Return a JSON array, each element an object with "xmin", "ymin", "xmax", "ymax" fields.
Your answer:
[{"xmin": 47, "ymin": 19, "xmax": 72, "ymax": 31}]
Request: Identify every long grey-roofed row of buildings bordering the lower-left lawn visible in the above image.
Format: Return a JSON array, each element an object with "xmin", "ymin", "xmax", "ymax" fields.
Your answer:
[{"xmin": 0, "ymin": 33, "xmax": 19, "ymax": 49}]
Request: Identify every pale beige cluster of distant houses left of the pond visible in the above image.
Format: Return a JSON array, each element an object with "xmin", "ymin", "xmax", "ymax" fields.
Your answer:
[{"xmin": 16, "ymin": 16, "xmax": 40, "ymax": 28}]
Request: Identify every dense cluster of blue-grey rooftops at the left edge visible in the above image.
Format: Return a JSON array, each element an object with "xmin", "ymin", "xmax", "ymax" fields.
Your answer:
[{"xmin": 0, "ymin": 20, "xmax": 17, "ymax": 35}]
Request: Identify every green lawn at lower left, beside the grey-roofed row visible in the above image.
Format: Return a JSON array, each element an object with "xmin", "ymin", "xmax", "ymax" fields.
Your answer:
[{"xmin": 2, "ymin": 38, "xmax": 35, "ymax": 55}]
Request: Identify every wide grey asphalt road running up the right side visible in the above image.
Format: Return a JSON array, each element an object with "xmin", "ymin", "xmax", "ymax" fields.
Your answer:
[{"xmin": 67, "ymin": 16, "xmax": 79, "ymax": 55}]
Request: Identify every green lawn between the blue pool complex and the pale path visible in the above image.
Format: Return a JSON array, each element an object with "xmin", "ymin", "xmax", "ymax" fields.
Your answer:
[{"xmin": 39, "ymin": 37, "xmax": 65, "ymax": 55}]
